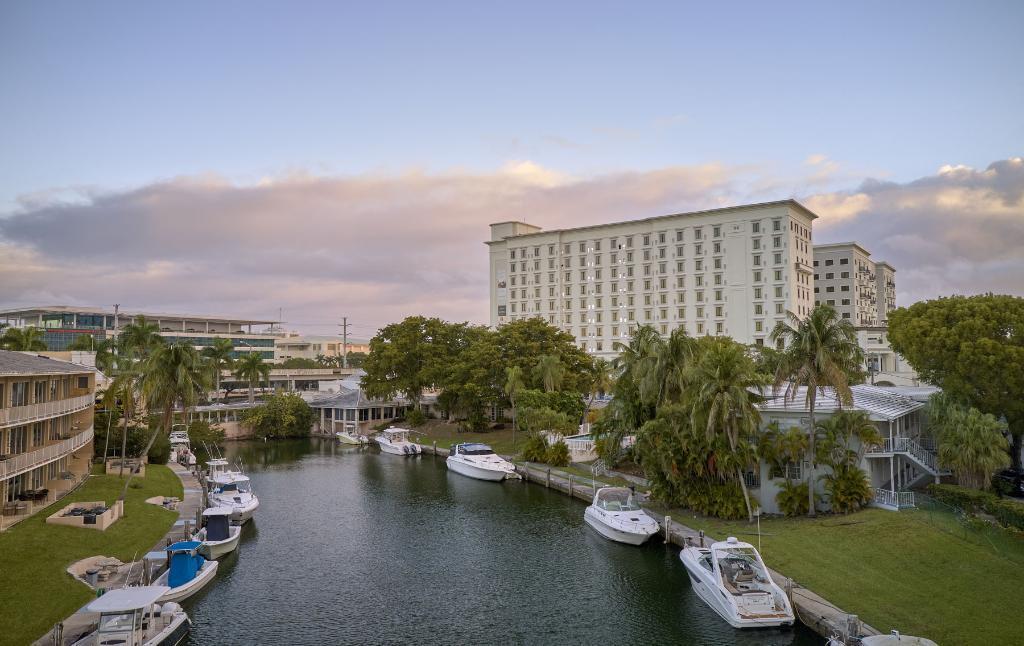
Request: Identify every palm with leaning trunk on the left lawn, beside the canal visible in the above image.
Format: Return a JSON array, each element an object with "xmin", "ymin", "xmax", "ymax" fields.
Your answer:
[{"xmin": 121, "ymin": 343, "xmax": 208, "ymax": 500}]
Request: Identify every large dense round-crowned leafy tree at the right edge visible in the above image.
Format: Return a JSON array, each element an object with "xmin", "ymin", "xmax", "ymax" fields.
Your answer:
[{"xmin": 889, "ymin": 294, "xmax": 1024, "ymax": 467}]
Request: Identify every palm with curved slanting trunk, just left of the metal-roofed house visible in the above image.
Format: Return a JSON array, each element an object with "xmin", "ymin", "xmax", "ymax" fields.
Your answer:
[{"xmin": 688, "ymin": 339, "xmax": 766, "ymax": 521}]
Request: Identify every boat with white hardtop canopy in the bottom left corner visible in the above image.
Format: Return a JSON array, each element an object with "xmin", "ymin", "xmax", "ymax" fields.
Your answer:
[{"xmin": 74, "ymin": 586, "xmax": 191, "ymax": 646}]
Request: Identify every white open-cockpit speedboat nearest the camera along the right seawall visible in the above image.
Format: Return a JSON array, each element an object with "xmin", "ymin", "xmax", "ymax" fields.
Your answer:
[{"xmin": 679, "ymin": 536, "xmax": 795, "ymax": 628}]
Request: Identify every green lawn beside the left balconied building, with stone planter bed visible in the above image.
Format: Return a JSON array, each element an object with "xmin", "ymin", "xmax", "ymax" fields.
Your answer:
[{"xmin": 0, "ymin": 465, "xmax": 182, "ymax": 644}]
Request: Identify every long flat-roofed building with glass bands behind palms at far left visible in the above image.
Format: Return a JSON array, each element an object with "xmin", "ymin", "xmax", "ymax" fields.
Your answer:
[{"xmin": 0, "ymin": 305, "xmax": 283, "ymax": 361}]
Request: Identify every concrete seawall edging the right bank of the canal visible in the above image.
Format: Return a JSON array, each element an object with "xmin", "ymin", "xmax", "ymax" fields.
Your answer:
[{"xmin": 421, "ymin": 442, "xmax": 879, "ymax": 644}]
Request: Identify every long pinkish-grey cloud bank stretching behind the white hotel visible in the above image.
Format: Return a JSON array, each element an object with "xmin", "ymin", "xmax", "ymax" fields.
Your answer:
[{"xmin": 0, "ymin": 156, "xmax": 1024, "ymax": 336}]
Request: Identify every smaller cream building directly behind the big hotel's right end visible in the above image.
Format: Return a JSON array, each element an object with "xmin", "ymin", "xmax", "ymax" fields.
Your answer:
[{"xmin": 814, "ymin": 243, "xmax": 896, "ymax": 328}]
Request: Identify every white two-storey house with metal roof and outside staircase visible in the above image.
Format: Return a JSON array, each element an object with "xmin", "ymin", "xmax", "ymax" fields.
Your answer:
[{"xmin": 748, "ymin": 384, "xmax": 948, "ymax": 513}]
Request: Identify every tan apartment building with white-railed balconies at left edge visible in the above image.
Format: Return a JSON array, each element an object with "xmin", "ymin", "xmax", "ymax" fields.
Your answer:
[{"xmin": 0, "ymin": 350, "xmax": 96, "ymax": 528}]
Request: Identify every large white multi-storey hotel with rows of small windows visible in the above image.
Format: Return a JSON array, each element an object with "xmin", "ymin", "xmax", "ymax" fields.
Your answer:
[{"xmin": 486, "ymin": 200, "xmax": 817, "ymax": 357}]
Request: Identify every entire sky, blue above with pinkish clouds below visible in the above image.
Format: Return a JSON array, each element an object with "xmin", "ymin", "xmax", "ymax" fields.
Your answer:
[{"xmin": 0, "ymin": 0, "xmax": 1024, "ymax": 337}]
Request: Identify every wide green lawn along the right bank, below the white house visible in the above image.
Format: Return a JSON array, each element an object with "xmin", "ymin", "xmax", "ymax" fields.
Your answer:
[{"xmin": 655, "ymin": 509, "xmax": 1024, "ymax": 644}]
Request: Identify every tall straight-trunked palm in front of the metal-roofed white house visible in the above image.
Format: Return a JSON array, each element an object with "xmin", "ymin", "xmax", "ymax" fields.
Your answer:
[{"xmin": 769, "ymin": 305, "xmax": 863, "ymax": 517}]
